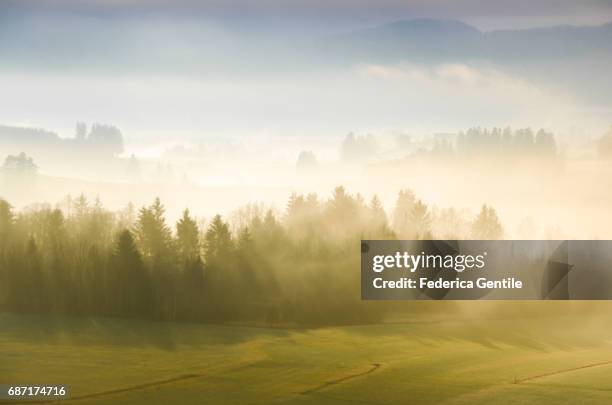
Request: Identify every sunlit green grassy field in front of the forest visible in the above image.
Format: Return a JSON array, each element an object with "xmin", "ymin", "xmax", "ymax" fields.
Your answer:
[{"xmin": 0, "ymin": 306, "xmax": 612, "ymax": 404}]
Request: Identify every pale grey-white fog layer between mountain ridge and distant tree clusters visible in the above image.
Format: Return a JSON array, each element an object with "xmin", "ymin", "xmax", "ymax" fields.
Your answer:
[{"xmin": 0, "ymin": 60, "xmax": 612, "ymax": 141}]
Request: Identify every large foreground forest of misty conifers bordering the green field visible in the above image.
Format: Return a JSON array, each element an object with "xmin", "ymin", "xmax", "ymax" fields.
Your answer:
[{"xmin": 0, "ymin": 187, "xmax": 503, "ymax": 325}]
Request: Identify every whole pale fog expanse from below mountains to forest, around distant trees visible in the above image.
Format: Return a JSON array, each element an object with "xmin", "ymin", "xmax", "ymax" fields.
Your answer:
[{"xmin": 0, "ymin": 64, "xmax": 612, "ymax": 238}]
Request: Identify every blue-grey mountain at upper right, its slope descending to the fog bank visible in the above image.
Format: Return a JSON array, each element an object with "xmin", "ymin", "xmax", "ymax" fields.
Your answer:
[{"xmin": 319, "ymin": 19, "xmax": 612, "ymax": 106}]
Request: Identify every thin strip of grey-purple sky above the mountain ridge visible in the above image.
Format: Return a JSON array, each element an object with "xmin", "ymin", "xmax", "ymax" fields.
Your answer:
[{"xmin": 0, "ymin": 0, "xmax": 612, "ymax": 30}]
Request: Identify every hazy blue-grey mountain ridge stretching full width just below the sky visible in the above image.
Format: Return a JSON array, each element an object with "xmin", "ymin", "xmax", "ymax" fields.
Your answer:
[{"xmin": 0, "ymin": 15, "xmax": 612, "ymax": 69}]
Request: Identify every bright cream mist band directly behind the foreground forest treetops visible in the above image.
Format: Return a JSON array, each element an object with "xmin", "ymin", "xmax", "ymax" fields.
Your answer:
[{"xmin": 0, "ymin": 123, "xmax": 612, "ymax": 239}]
